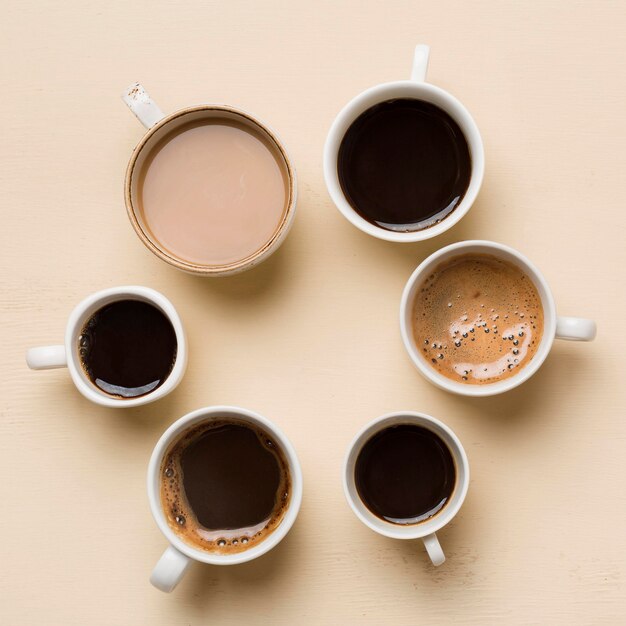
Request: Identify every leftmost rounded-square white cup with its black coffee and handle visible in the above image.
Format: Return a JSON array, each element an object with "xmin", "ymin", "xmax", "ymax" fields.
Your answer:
[{"xmin": 26, "ymin": 286, "xmax": 187, "ymax": 408}]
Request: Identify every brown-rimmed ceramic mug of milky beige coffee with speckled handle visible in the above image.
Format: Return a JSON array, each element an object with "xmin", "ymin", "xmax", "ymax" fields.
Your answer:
[{"xmin": 123, "ymin": 83, "xmax": 296, "ymax": 276}]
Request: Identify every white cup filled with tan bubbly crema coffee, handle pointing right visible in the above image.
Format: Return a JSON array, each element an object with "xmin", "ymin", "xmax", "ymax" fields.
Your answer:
[{"xmin": 400, "ymin": 241, "xmax": 596, "ymax": 397}]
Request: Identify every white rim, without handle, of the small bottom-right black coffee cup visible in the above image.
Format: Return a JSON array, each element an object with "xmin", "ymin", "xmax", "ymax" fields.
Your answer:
[{"xmin": 342, "ymin": 411, "xmax": 470, "ymax": 539}]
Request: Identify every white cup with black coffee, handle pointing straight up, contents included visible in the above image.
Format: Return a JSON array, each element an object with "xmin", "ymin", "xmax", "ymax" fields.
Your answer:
[{"xmin": 324, "ymin": 45, "xmax": 485, "ymax": 242}]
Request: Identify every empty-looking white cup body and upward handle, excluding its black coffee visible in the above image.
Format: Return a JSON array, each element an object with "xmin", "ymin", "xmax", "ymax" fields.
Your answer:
[{"xmin": 324, "ymin": 45, "xmax": 485, "ymax": 242}]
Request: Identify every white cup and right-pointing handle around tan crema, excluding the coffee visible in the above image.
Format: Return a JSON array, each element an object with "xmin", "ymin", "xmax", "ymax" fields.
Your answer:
[{"xmin": 400, "ymin": 241, "xmax": 596, "ymax": 397}]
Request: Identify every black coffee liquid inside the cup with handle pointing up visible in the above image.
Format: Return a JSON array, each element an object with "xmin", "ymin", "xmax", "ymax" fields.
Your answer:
[{"xmin": 337, "ymin": 98, "xmax": 472, "ymax": 232}]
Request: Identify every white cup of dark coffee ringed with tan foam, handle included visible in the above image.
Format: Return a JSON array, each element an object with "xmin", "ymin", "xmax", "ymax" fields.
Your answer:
[{"xmin": 148, "ymin": 406, "xmax": 302, "ymax": 592}]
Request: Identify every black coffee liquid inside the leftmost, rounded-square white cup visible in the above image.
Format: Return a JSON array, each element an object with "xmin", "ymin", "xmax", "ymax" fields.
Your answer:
[{"xmin": 78, "ymin": 300, "xmax": 178, "ymax": 398}]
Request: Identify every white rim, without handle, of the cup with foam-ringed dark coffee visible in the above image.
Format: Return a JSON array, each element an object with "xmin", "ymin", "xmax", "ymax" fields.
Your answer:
[{"xmin": 147, "ymin": 405, "xmax": 302, "ymax": 565}]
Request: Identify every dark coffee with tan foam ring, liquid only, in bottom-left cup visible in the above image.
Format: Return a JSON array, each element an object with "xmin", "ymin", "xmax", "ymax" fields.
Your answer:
[{"xmin": 161, "ymin": 419, "xmax": 291, "ymax": 554}]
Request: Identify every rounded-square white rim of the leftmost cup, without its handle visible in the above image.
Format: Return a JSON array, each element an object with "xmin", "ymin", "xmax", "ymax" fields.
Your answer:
[{"xmin": 65, "ymin": 285, "xmax": 187, "ymax": 408}]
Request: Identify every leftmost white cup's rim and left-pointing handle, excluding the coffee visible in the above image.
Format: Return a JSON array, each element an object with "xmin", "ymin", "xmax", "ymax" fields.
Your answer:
[{"xmin": 26, "ymin": 286, "xmax": 187, "ymax": 408}]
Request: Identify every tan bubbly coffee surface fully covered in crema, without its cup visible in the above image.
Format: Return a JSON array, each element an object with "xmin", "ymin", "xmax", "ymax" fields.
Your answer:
[{"xmin": 413, "ymin": 254, "xmax": 543, "ymax": 385}]
